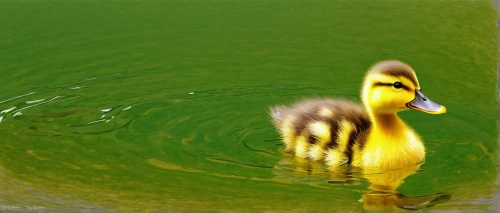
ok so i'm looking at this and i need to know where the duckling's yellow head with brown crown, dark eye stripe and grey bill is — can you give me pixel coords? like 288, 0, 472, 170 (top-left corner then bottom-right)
361, 61, 446, 114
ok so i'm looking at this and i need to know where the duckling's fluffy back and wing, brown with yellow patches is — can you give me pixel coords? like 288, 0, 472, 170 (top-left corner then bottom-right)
270, 99, 371, 165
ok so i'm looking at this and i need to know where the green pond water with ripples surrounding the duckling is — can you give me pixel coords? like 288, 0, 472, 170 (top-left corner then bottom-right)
0, 0, 498, 211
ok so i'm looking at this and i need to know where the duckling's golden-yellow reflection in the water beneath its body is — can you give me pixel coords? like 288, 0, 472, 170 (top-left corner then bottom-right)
275, 156, 451, 211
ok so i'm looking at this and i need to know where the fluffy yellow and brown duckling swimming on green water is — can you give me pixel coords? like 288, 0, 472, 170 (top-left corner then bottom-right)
270, 60, 446, 169
